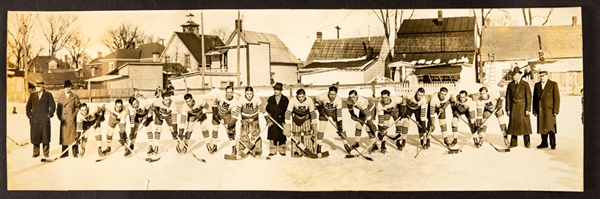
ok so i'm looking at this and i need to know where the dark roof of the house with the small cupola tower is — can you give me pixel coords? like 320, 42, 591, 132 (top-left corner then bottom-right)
175, 32, 224, 61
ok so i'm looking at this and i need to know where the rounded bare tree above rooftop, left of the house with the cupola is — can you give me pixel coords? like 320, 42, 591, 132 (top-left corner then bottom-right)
102, 22, 148, 51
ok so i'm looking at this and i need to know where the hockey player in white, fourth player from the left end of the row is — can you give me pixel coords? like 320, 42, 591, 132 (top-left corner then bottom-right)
148, 93, 177, 159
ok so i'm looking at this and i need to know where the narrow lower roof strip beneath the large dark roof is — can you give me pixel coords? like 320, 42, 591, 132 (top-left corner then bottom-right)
392, 51, 475, 65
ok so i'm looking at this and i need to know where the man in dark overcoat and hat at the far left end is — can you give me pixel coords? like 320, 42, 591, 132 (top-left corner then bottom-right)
25, 81, 56, 158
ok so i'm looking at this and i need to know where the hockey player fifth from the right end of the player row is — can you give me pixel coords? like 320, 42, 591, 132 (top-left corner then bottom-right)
376, 90, 402, 153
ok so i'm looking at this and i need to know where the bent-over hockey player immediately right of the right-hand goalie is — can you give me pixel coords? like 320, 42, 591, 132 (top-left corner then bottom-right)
315, 86, 352, 153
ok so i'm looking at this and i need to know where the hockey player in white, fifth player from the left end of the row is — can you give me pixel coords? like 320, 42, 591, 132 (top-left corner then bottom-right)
175, 93, 211, 153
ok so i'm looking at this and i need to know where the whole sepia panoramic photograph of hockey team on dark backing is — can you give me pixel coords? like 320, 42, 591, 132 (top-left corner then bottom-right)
5, 7, 590, 192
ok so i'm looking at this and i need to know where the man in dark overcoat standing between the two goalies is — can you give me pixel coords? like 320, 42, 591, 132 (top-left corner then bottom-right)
266, 82, 289, 156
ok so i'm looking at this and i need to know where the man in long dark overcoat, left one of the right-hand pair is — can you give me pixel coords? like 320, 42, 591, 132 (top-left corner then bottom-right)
506, 66, 532, 148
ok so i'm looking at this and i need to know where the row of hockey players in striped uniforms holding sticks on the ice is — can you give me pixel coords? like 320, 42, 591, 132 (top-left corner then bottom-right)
32, 86, 529, 162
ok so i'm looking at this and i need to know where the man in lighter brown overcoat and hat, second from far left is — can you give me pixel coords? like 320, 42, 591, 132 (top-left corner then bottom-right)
56, 80, 81, 158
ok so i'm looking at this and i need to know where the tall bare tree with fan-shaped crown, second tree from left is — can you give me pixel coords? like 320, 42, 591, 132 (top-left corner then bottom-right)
40, 14, 78, 57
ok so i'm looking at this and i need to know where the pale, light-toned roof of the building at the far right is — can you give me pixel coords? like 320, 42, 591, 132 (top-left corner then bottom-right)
481, 26, 583, 61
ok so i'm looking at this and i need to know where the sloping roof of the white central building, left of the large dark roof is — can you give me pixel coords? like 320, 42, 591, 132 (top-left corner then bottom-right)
306, 36, 385, 63
